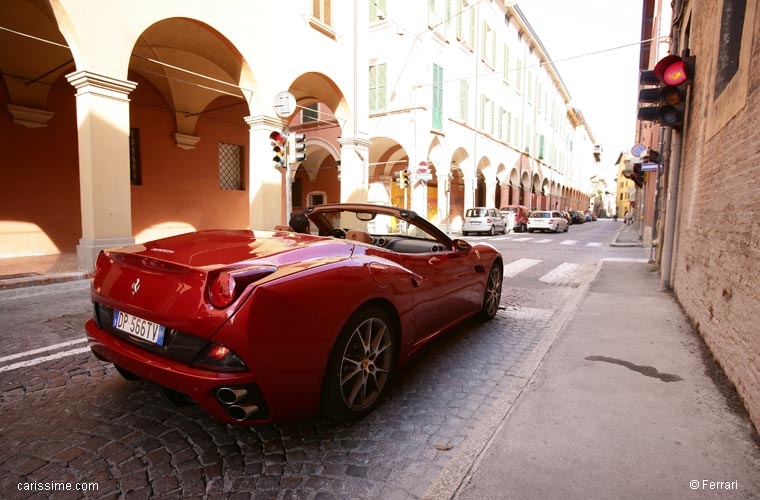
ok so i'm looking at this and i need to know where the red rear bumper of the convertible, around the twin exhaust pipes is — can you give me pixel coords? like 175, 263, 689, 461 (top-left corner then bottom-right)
85, 320, 271, 425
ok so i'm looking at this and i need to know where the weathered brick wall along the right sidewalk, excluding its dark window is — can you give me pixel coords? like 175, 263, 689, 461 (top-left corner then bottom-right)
672, 2, 760, 429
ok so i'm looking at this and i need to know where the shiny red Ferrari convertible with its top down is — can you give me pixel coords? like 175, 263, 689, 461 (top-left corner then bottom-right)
86, 204, 503, 424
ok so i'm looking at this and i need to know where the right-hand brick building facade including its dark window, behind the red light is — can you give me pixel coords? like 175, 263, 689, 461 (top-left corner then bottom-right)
644, 0, 760, 429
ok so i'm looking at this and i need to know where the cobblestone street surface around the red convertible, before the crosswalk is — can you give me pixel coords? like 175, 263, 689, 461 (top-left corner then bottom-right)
0, 272, 581, 500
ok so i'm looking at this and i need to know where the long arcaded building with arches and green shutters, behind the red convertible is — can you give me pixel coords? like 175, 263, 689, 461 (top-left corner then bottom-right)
0, 0, 598, 269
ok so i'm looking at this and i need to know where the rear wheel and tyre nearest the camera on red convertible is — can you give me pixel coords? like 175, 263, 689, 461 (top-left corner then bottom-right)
322, 306, 398, 422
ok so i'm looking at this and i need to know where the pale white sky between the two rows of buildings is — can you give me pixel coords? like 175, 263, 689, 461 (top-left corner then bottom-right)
515, 0, 643, 181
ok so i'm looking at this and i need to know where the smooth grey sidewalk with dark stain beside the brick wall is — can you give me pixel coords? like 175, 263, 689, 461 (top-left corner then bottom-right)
455, 260, 760, 500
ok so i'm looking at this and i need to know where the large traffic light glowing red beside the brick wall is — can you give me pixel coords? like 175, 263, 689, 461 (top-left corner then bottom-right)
638, 54, 694, 130
